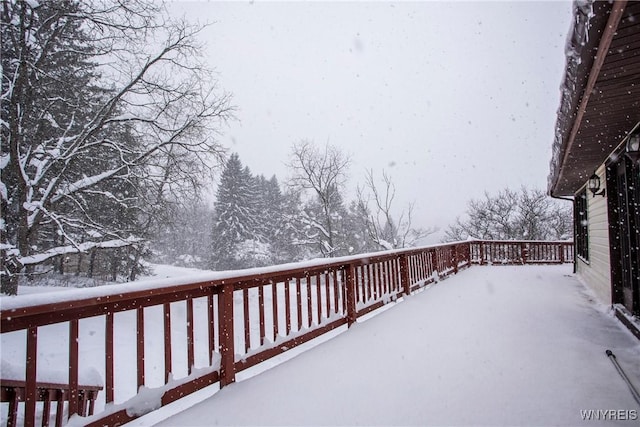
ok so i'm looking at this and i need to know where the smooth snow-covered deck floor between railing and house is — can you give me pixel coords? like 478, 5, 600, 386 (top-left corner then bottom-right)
152, 265, 640, 426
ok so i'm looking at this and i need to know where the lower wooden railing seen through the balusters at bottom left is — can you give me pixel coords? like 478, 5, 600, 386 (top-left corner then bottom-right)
0, 379, 102, 427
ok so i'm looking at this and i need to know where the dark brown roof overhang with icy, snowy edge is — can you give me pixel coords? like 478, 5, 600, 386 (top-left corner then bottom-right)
549, 1, 640, 196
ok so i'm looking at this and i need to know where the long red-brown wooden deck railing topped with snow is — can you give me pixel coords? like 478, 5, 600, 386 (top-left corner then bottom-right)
0, 241, 573, 426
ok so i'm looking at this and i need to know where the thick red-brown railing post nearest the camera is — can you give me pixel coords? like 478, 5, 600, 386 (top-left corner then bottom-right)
218, 283, 236, 388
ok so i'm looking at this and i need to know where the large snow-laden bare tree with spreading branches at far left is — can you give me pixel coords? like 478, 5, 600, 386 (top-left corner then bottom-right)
0, 0, 232, 293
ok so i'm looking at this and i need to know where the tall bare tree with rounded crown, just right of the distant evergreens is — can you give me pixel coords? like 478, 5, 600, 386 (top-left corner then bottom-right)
288, 141, 350, 256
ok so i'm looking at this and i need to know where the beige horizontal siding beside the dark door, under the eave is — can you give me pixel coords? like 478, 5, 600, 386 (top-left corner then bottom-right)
576, 166, 612, 304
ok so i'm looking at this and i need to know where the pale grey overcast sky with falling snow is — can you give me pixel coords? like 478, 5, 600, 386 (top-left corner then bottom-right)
170, 1, 571, 242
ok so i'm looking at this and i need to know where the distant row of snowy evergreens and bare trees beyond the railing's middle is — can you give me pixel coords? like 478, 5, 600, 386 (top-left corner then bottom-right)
154, 145, 434, 270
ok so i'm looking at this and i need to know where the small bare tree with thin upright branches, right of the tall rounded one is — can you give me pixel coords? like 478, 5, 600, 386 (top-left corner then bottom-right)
357, 170, 436, 249
